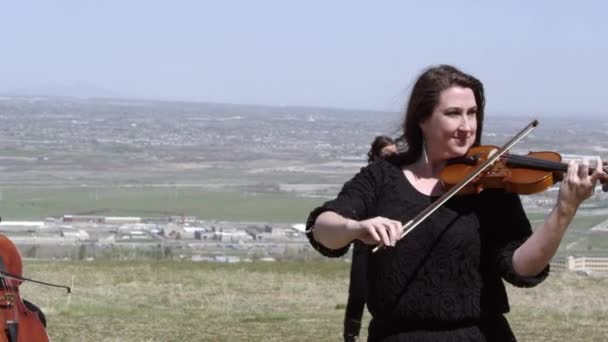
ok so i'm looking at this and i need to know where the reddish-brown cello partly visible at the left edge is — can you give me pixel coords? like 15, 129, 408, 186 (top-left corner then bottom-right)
0, 234, 49, 342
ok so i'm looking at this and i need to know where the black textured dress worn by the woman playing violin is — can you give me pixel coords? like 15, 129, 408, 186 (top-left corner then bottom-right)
307, 161, 549, 341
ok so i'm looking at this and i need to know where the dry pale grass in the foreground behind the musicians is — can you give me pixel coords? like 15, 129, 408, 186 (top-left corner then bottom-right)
16, 260, 608, 341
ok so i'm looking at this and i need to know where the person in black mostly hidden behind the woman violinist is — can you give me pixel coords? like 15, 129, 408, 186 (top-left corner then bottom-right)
343, 135, 397, 342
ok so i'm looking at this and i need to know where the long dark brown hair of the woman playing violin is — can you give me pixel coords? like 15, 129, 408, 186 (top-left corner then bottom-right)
391, 65, 485, 164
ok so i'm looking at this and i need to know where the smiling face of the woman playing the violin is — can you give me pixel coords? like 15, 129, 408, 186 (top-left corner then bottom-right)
420, 86, 477, 161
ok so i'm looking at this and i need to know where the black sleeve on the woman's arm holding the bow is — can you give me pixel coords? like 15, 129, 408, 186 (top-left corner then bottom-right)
306, 163, 382, 257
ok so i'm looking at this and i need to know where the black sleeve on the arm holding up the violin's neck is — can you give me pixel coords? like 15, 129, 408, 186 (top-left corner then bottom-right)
486, 191, 549, 287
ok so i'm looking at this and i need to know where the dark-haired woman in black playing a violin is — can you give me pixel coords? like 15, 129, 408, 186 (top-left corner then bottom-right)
307, 65, 607, 341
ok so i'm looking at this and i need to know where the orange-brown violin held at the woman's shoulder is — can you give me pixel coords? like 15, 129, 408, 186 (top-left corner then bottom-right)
439, 145, 608, 195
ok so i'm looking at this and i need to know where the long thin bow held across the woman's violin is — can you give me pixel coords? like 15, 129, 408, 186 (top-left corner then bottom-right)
372, 120, 538, 253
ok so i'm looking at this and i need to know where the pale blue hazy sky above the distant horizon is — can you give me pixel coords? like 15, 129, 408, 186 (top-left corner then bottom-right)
0, 0, 608, 118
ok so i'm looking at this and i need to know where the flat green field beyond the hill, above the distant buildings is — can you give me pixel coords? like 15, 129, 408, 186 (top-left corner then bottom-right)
0, 187, 323, 222
